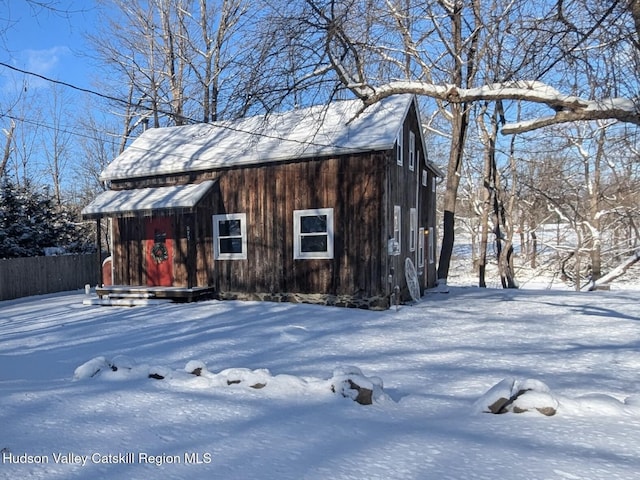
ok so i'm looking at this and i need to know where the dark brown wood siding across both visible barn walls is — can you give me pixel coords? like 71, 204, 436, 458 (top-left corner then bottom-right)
106, 96, 444, 299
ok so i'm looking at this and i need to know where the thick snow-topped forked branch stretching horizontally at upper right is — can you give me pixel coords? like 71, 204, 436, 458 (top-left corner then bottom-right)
356, 80, 640, 134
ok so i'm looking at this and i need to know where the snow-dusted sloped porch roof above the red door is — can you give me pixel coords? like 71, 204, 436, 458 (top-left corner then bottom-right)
82, 180, 216, 219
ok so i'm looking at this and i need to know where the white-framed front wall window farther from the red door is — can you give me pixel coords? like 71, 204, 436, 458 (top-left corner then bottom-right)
293, 208, 333, 260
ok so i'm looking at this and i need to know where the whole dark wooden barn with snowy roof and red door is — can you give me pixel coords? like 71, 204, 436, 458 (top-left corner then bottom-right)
83, 95, 442, 308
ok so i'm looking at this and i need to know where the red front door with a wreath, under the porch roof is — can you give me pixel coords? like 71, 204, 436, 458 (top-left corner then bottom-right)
145, 217, 173, 287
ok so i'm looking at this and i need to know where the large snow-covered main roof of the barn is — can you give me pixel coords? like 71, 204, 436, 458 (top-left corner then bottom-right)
101, 95, 414, 181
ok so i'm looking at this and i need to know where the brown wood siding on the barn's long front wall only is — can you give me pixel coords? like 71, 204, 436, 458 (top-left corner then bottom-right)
114, 152, 392, 297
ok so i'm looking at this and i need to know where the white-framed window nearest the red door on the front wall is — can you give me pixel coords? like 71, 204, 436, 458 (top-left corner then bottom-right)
213, 213, 247, 260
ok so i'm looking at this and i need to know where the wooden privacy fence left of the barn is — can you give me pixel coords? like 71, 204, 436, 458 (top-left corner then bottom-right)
0, 253, 100, 300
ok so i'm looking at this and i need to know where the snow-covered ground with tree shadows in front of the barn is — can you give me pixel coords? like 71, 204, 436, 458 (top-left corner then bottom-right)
0, 287, 640, 480
